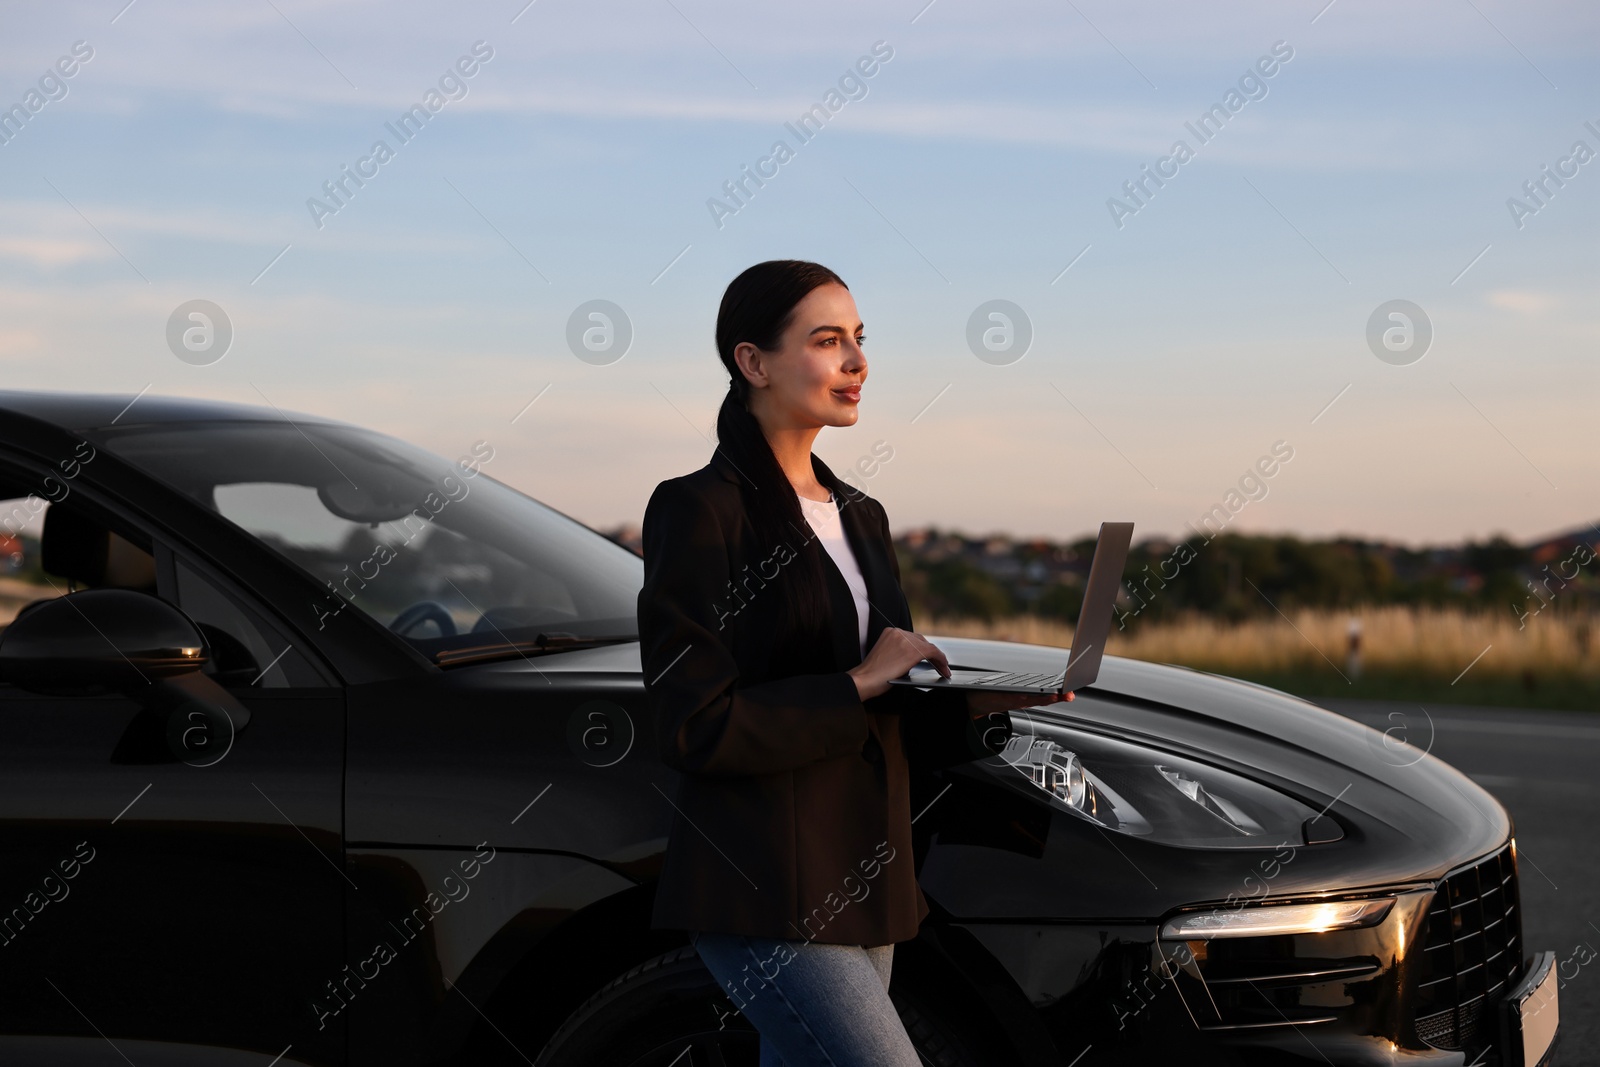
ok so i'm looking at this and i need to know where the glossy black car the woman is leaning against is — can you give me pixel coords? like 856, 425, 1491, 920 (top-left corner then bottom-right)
0, 392, 1557, 1067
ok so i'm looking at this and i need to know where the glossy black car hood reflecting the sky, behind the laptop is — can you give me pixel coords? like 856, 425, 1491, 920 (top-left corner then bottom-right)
472, 635, 1512, 913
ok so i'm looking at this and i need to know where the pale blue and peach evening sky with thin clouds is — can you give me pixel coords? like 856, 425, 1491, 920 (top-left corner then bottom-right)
0, 0, 1600, 544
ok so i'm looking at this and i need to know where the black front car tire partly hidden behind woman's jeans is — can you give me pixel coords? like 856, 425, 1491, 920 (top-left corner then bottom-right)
534, 945, 992, 1067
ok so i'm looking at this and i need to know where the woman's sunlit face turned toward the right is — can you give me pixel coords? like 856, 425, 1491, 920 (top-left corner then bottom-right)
734, 283, 867, 430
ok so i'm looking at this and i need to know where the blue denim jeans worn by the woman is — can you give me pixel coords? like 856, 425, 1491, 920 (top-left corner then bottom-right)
691, 933, 922, 1067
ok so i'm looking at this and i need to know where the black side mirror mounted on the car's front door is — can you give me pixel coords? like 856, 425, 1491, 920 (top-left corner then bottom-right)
0, 589, 250, 766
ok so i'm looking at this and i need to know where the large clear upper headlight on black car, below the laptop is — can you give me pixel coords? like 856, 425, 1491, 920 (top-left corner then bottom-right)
978, 712, 1318, 848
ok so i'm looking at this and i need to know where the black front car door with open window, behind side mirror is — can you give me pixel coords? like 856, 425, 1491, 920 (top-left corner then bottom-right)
0, 445, 350, 1067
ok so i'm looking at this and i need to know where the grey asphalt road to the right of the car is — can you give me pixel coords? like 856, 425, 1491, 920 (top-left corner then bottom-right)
1318, 701, 1600, 1067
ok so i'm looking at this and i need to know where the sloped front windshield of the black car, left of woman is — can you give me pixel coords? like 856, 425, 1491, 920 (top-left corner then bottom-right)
96, 421, 643, 659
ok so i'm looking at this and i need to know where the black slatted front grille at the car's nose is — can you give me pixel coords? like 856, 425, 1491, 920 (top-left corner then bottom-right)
1416, 846, 1522, 1056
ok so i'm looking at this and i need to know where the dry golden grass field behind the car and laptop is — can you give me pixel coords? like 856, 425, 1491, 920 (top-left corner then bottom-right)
917, 606, 1600, 710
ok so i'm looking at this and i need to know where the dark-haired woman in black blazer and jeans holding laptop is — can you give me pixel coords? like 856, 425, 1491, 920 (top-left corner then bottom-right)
638, 259, 1021, 1067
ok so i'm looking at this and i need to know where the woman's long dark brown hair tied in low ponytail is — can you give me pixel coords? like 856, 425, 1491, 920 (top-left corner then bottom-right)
717, 259, 850, 652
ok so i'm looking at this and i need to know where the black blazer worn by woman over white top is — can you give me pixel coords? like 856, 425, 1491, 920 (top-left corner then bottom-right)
638, 450, 995, 945
